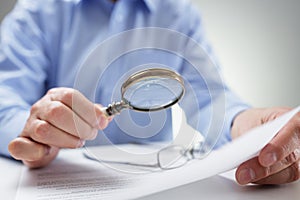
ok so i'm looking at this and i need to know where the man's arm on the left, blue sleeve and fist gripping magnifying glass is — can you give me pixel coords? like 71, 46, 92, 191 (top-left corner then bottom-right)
0, 1, 109, 167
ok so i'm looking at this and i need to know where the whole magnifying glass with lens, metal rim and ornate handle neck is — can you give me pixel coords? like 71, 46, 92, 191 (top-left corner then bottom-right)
102, 68, 185, 117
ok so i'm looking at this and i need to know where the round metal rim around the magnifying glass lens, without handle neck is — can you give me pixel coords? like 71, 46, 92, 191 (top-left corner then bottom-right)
121, 68, 185, 112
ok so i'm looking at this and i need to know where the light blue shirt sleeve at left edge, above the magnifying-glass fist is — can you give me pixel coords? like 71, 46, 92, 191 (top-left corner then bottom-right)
0, 1, 49, 156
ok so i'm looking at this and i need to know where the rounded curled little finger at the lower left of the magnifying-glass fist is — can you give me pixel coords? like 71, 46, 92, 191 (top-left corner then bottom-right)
8, 137, 50, 161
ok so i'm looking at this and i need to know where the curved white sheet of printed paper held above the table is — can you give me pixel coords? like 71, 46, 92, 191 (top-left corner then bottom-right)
16, 107, 300, 200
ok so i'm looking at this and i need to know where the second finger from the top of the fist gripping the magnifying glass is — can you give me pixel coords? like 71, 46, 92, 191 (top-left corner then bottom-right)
32, 101, 97, 140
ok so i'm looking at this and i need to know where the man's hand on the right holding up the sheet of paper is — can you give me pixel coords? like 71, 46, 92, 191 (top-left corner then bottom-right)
232, 108, 300, 185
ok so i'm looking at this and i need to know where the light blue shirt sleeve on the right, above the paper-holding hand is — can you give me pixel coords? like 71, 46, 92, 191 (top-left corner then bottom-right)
176, 3, 250, 150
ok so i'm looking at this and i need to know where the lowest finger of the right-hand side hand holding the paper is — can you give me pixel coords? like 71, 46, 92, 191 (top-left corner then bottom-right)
236, 149, 300, 185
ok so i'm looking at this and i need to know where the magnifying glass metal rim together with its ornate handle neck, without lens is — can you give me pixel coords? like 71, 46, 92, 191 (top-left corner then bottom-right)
102, 68, 185, 117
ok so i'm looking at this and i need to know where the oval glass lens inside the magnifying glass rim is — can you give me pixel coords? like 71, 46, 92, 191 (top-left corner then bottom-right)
123, 77, 183, 110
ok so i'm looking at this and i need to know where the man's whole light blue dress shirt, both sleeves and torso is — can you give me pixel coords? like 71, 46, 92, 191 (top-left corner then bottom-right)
0, 0, 248, 156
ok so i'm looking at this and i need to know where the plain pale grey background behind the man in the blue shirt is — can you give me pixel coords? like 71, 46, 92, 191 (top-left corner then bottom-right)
0, 0, 300, 107
